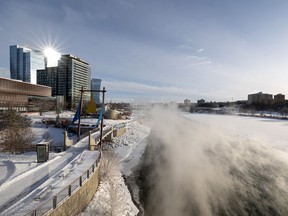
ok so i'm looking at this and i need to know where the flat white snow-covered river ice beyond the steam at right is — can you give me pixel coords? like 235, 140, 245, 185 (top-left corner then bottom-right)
182, 113, 288, 151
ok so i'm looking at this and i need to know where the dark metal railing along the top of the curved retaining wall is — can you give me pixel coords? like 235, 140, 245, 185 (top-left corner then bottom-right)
25, 155, 101, 216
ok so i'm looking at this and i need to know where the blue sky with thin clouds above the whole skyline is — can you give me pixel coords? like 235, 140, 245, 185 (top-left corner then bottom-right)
0, 0, 288, 102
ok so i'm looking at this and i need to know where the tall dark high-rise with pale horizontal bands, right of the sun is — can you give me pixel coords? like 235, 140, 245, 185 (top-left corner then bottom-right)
58, 54, 91, 109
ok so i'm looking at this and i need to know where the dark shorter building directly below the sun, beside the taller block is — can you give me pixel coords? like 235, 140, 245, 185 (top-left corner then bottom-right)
37, 67, 58, 97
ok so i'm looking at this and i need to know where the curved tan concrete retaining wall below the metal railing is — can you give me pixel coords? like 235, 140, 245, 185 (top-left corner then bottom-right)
48, 163, 100, 216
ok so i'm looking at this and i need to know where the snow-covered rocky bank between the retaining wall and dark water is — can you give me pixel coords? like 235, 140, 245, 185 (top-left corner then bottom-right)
80, 117, 150, 216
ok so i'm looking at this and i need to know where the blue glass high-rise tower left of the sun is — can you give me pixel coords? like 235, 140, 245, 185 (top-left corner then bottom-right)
10, 45, 45, 84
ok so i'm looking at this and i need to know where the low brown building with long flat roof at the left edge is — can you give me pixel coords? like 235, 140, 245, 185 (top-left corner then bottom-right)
0, 77, 51, 112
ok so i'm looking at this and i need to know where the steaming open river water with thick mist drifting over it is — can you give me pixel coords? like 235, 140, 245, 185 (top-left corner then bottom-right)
142, 109, 288, 216
